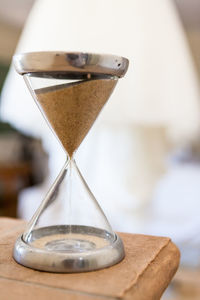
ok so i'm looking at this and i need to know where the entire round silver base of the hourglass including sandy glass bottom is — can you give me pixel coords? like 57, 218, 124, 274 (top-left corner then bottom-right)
13, 225, 125, 273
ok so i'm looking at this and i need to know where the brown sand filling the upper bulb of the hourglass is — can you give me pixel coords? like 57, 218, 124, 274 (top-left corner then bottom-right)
35, 79, 117, 157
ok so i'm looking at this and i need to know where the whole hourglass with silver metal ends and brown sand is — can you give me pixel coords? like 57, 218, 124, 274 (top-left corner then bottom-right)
13, 52, 128, 272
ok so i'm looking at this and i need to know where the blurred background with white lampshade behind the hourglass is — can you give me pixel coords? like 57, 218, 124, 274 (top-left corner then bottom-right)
0, 0, 200, 300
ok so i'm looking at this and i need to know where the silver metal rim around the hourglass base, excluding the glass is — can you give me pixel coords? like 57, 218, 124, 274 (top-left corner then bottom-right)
13, 234, 125, 273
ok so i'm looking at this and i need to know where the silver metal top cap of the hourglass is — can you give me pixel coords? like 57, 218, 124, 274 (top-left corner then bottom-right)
14, 51, 129, 78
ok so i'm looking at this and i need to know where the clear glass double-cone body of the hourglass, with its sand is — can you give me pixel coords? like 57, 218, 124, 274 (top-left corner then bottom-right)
23, 75, 116, 253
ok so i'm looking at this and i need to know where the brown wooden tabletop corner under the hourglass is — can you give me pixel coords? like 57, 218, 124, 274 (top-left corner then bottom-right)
0, 218, 179, 300
